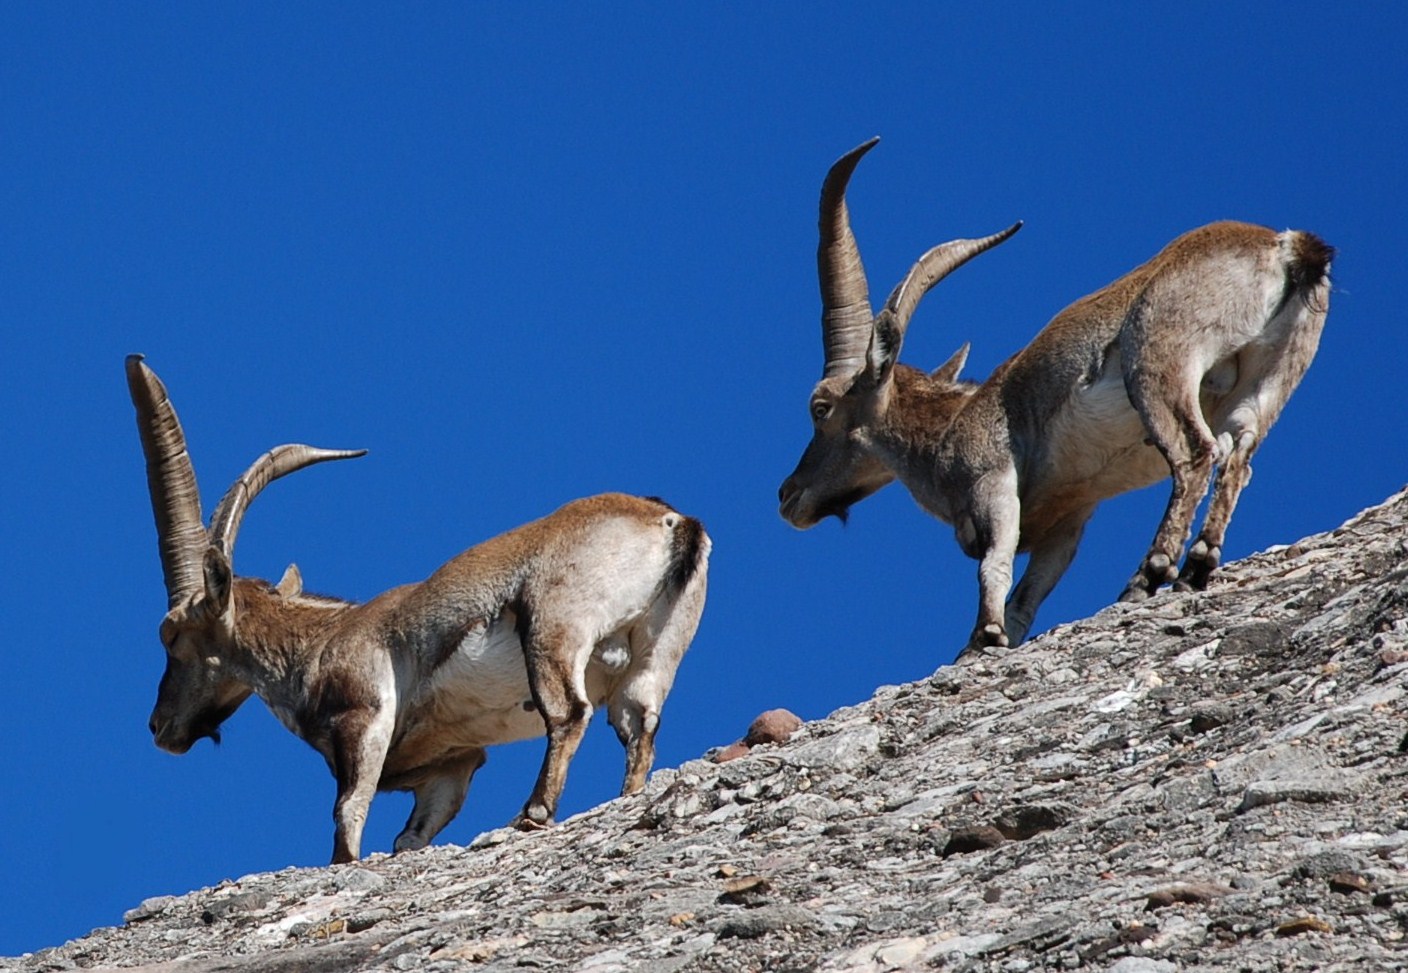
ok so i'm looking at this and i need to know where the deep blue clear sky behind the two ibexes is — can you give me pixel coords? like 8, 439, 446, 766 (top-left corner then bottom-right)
0, 3, 1408, 955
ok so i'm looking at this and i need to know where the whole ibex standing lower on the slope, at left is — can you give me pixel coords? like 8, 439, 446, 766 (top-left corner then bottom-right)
127, 355, 710, 863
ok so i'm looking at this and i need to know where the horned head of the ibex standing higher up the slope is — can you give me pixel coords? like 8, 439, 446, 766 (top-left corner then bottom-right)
777, 138, 1022, 529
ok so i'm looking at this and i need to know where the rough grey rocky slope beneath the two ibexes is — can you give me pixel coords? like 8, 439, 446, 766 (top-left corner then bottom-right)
11, 493, 1408, 973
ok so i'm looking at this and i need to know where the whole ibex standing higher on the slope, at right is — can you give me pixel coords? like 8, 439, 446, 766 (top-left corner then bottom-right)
779, 139, 1333, 648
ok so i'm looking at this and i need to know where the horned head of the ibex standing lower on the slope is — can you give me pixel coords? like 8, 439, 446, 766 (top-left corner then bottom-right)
127, 355, 366, 753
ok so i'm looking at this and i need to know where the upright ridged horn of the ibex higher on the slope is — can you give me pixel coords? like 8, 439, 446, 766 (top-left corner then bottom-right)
817, 135, 880, 377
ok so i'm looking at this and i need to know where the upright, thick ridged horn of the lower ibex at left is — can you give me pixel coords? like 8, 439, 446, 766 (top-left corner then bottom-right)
127, 355, 210, 607
